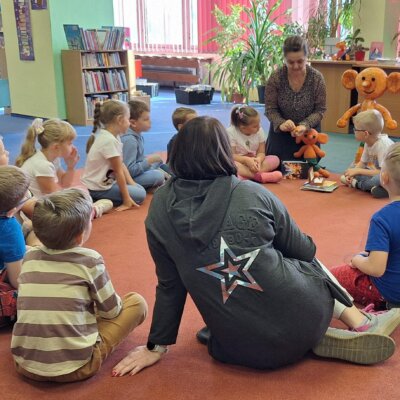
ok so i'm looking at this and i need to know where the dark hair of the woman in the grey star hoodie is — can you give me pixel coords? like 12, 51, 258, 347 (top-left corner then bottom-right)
170, 116, 237, 180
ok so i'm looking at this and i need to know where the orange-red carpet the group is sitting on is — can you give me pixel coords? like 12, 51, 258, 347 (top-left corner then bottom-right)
0, 177, 400, 400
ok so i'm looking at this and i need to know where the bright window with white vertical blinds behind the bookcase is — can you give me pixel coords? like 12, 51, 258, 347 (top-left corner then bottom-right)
114, 0, 198, 53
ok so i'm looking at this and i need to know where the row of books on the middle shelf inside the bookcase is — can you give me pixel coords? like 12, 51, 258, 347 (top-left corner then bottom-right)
82, 69, 128, 93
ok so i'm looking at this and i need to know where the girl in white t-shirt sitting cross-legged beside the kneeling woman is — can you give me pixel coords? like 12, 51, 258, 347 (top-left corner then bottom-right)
227, 105, 282, 183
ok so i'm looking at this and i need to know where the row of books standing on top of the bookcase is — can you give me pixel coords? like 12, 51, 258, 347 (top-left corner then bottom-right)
64, 24, 130, 51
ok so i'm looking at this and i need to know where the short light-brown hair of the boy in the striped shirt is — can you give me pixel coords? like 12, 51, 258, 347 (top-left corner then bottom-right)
32, 188, 93, 250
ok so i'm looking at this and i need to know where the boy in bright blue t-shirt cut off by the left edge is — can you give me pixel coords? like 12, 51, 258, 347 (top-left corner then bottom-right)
0, 165, 29, 288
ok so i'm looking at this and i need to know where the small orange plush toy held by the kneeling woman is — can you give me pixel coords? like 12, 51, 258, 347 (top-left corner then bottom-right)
293, 129, 329, 178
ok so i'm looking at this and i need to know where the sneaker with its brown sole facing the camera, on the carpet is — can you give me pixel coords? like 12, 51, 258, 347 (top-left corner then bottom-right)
312, 328, 396, 365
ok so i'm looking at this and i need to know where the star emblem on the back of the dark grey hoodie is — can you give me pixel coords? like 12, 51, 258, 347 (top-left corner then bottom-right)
197, 237, 263, 303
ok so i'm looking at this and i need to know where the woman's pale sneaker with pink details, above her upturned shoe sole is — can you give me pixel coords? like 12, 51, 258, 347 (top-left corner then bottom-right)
352, 304, 400, 335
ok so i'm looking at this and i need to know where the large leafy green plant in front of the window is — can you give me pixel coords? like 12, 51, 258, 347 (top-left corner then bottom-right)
211, 0, 301, 100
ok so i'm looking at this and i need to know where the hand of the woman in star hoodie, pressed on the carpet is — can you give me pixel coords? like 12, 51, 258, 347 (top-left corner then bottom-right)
111, 346, 161, 376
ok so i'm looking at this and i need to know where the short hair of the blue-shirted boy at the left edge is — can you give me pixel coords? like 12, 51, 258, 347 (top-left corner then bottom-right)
0, 165, 29, 214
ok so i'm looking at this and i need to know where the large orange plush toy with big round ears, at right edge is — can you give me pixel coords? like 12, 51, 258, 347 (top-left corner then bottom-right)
337, 67, 400, 129
